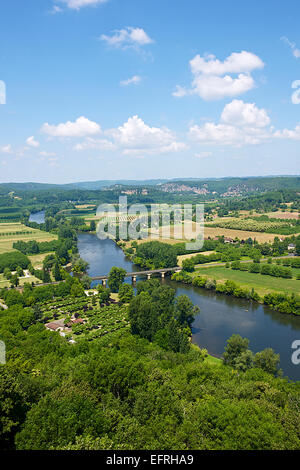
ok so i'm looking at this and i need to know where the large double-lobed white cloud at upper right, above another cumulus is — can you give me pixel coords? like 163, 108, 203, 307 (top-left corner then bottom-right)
173, 51, 264, 101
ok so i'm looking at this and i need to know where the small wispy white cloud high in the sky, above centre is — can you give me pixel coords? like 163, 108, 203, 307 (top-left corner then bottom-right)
100, 27, 154, 49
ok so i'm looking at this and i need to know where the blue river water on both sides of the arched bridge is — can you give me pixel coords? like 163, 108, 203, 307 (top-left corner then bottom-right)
78, 234, 300, 380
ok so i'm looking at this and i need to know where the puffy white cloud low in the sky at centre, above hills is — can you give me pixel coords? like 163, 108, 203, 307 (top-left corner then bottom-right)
110, 116, 187, 155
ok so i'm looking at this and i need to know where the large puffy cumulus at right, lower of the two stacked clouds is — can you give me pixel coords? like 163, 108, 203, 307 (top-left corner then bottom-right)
189, 100, 271, 147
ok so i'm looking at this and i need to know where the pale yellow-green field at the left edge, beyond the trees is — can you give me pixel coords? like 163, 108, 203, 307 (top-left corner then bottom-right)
0, 223, 57, 254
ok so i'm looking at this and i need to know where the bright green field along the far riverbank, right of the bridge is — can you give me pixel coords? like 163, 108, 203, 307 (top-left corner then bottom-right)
194, 266, 300, 295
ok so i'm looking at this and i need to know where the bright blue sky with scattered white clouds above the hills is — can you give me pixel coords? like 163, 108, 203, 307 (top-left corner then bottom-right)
0, 0, 300, 183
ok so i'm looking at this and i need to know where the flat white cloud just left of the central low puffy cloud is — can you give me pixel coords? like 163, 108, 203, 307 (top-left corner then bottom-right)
41, 116, 101, 137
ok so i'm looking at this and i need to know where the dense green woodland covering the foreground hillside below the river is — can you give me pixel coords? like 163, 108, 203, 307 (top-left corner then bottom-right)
0, 281, 300, 450
